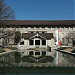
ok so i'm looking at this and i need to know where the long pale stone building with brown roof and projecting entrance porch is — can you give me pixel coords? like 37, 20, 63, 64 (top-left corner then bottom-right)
0, 20, 75, 55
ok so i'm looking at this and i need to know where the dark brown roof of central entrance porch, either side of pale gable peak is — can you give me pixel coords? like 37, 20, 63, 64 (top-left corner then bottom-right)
22, 33, 53, 39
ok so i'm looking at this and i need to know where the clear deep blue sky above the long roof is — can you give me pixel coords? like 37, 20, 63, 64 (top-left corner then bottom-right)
6, 0, 75, 20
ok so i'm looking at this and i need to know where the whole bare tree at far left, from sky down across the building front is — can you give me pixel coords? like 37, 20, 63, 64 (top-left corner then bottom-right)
0, 0, 15, 46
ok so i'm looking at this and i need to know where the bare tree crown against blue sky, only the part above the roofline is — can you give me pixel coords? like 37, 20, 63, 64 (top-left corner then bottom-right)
0, 0, 15, 20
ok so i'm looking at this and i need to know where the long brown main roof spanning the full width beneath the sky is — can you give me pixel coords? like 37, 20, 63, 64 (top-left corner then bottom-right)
0, 20, 75, 25
